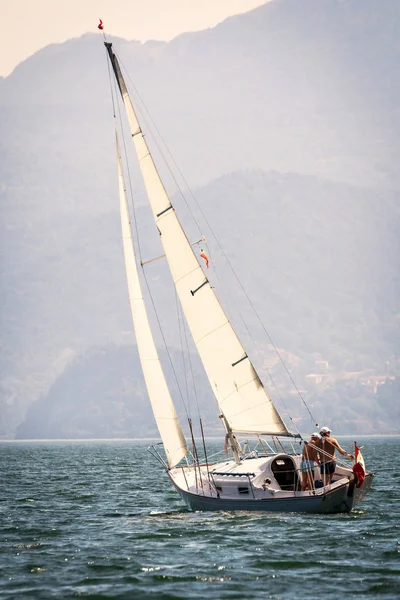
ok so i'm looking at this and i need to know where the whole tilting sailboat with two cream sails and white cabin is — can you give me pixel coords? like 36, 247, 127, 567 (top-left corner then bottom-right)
99, 34, 373, 513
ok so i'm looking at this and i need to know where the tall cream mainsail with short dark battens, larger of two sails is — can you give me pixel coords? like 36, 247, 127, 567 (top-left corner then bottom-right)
105, 42, 290, 435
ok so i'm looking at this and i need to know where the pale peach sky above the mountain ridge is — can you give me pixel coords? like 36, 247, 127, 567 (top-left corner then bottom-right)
0, 0, 271, 76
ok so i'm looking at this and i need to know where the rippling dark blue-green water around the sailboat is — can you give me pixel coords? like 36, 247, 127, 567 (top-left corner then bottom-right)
0, 438, 400, 600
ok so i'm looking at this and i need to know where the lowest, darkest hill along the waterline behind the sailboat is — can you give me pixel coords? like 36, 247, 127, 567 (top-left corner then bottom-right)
16, 346, 400, 444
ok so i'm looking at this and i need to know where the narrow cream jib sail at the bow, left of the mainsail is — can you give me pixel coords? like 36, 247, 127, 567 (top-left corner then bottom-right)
116, 133, 188, 467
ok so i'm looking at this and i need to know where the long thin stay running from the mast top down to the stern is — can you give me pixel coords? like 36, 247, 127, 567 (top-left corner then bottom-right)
114, 49, 317, 424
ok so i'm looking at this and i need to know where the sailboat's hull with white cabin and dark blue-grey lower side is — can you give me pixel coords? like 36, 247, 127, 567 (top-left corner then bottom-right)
168, 454, 373, 513
